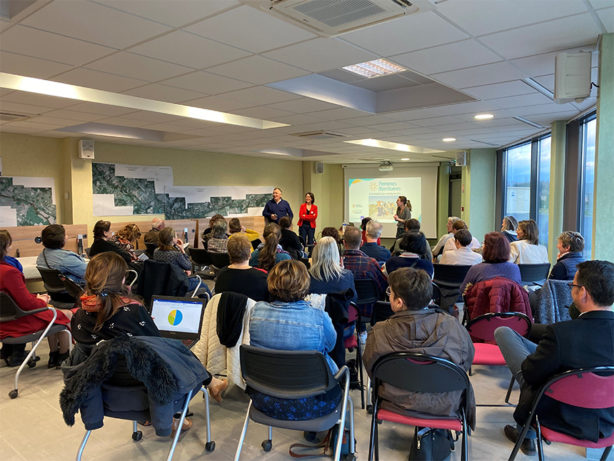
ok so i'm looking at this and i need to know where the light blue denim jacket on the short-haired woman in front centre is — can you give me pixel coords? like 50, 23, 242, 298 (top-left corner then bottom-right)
249, 301, 338, 373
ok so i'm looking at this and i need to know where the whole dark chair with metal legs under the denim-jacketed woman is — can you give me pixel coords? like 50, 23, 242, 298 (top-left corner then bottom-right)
235, 345, 355, 461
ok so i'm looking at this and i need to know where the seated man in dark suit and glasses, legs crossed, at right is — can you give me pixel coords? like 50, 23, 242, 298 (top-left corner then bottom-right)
495, 261, 614, 455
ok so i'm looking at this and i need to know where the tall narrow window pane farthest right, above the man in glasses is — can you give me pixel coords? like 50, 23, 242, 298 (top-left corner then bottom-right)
578, 114, 597, 258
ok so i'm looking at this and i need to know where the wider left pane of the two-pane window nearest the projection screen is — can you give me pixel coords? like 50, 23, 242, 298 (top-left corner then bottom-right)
503, 142, 531, 221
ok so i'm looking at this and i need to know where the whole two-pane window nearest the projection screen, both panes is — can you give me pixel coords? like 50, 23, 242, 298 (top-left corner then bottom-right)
503, 134, 551, 244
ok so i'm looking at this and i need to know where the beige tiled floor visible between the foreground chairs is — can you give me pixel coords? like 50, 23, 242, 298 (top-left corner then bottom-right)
0, 345, 614, 461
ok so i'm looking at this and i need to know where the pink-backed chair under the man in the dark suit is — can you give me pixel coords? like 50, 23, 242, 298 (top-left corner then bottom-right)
509, 366, 614, 461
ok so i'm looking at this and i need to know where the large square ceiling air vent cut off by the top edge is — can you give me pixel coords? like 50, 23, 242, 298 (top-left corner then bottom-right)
241, 0, 432, 37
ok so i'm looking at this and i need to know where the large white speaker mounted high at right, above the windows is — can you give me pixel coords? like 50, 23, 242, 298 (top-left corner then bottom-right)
554, 51, 592, 104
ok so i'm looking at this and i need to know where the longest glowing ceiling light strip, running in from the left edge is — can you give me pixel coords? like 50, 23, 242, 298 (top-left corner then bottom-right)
0, 72, 288, 130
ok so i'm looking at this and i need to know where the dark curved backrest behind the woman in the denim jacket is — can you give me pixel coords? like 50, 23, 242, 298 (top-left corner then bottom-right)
240, 345, 337, 399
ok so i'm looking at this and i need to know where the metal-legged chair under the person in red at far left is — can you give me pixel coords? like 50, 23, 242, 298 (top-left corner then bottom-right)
0, 292, 72, 399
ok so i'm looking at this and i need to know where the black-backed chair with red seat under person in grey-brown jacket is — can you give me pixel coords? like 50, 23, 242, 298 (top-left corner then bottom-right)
369, 352, 471, 461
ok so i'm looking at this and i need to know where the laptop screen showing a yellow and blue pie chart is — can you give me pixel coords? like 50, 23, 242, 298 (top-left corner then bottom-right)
151, 296, 205, 340
